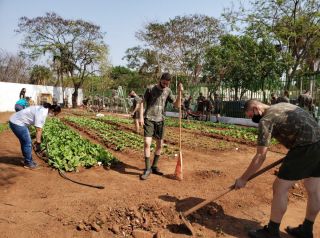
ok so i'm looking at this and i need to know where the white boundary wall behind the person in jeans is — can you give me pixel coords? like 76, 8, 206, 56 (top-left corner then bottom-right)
0, 82, 83, 112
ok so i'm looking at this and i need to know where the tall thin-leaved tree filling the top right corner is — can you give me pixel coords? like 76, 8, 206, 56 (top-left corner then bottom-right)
226, 0, 320, 89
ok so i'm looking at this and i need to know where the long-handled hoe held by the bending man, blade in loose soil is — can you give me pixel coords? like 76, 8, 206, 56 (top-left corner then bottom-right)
179, 158, 284, 235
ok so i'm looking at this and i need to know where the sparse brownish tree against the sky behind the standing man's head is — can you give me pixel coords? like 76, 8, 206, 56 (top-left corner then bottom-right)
137, 15, 222, 83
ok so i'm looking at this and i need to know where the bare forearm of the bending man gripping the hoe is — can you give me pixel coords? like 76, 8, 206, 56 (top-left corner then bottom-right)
234, 146, 268, 189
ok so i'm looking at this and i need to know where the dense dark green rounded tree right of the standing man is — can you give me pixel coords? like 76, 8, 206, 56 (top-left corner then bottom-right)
204, 34, 283, 100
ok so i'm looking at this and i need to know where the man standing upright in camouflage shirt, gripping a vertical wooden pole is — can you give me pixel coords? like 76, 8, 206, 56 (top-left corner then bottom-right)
140, 73, 183, 180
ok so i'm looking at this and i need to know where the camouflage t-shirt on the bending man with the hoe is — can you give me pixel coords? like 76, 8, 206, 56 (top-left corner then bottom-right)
258, 103, 320, 149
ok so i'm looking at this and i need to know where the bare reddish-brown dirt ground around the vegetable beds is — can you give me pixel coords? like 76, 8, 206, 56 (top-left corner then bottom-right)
0, 110, 320, 238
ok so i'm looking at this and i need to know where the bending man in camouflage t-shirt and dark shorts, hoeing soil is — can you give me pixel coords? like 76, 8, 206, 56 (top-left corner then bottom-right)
234, 100, 320, 238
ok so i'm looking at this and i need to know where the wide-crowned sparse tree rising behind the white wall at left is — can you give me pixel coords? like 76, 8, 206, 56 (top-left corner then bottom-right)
17, 13, 108, 107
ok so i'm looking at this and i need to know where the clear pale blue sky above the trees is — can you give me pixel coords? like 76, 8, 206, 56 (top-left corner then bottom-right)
0, 0, 242, 65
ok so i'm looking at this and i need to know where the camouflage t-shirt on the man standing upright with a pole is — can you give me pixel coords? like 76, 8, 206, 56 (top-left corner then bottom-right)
143, 85, 175, 122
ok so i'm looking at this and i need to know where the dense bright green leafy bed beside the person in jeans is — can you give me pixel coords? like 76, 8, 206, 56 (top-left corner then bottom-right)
42, 119, 117, 171
